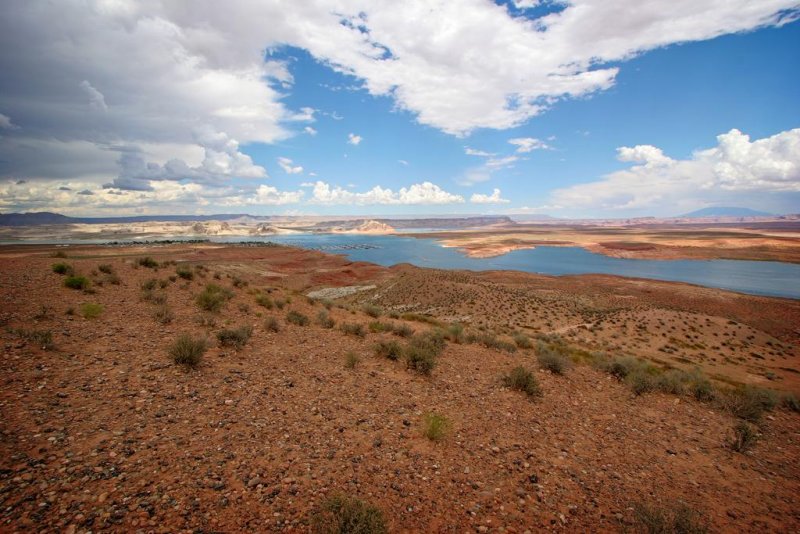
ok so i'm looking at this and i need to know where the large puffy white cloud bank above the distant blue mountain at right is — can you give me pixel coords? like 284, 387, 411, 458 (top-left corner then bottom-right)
552, 128, 800, 215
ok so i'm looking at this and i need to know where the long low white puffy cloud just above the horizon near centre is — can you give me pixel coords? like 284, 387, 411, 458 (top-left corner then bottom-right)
311, 181, 464, 206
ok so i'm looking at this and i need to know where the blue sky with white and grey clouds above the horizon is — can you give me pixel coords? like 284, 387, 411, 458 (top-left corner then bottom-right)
0, 0, 800, 218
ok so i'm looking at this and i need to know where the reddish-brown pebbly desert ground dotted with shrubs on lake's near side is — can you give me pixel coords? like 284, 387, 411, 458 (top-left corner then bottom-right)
0, 245, 800, 533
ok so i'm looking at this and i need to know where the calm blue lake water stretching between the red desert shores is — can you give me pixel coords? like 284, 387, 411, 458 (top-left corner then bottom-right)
206, 234, 800, 299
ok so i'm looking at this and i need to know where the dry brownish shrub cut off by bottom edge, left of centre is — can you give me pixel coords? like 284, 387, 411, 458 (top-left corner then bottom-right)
311, 495, 388, 534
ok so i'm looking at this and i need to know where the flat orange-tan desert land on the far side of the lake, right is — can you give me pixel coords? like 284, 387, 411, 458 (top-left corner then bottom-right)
407, 219, 800, 263
